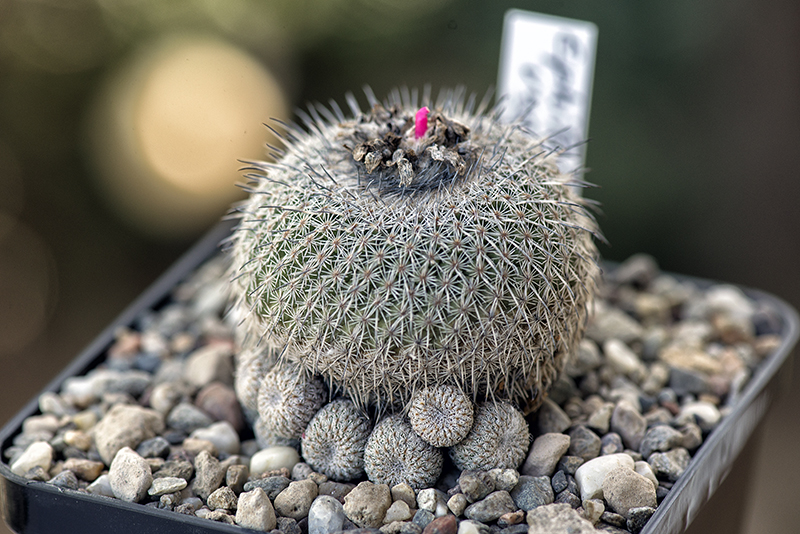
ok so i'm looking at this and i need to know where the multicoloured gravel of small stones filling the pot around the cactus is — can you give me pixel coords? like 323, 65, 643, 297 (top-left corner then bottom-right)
3, 255, 780, 534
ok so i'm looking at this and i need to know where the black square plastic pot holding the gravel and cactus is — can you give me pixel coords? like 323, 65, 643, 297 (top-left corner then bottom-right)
0, 223, 800, 534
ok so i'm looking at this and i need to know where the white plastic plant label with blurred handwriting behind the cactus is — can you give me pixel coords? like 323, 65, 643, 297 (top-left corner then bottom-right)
497, 9, 597, 172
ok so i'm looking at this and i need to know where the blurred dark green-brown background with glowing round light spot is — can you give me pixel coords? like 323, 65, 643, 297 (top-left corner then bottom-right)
0, 0, 800, 532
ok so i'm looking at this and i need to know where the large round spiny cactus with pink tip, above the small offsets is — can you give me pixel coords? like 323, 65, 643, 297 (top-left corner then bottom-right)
225, 87, 599, 412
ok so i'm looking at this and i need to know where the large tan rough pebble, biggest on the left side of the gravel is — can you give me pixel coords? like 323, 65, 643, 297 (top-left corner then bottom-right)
92, 404, 164, 465
